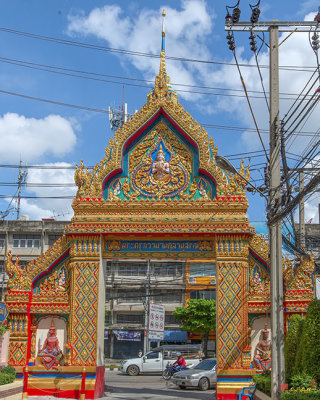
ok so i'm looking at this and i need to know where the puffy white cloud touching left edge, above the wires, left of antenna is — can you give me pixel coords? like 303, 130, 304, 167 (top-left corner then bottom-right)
0, 113, 76, 162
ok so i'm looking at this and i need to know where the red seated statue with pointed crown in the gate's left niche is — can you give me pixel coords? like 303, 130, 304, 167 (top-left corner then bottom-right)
38, 320, 63, 370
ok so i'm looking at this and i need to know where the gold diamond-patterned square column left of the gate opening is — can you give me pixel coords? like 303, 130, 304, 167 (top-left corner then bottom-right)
68, 235, 105, 398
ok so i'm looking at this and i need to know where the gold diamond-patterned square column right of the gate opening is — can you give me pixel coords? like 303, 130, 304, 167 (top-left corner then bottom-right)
217, 235, 253, 400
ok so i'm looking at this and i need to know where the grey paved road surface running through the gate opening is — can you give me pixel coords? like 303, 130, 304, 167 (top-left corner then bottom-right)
29, 371, 216, 400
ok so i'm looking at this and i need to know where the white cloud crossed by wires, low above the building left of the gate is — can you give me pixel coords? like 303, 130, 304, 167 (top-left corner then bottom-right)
21, 162, 76, 220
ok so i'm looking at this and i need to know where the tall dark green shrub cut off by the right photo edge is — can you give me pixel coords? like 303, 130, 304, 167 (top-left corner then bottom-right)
300, 299, 320, 384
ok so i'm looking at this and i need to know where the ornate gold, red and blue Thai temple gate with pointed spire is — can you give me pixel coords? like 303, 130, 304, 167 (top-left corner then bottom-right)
6, 22, 312, 400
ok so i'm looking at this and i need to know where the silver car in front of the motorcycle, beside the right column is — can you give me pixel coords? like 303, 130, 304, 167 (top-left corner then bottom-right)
172, 358, 217, 390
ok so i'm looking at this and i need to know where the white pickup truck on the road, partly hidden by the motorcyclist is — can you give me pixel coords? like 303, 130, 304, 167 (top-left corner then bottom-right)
121, 349, 201, 376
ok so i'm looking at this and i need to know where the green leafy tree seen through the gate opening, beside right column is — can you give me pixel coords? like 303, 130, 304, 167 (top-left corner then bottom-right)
173, 299, 216, 355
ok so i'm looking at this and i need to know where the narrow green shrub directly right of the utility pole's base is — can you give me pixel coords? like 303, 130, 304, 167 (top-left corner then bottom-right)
284, 315, 303, 380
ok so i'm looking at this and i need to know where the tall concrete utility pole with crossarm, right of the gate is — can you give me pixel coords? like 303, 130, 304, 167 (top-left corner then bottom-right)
225, 14, 320, 400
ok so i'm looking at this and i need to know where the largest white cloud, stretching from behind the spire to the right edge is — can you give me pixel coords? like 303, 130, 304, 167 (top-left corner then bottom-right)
68, 4, 319, 228
